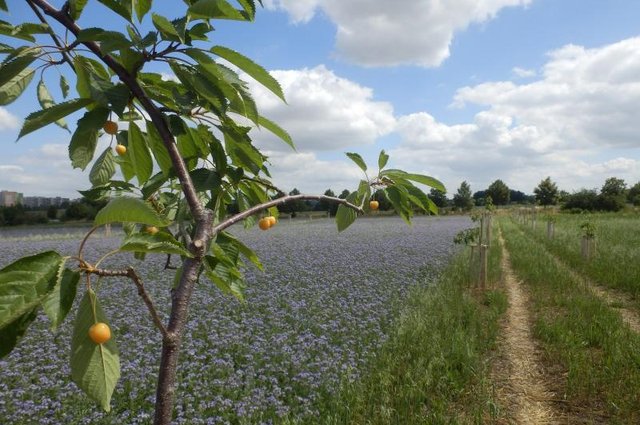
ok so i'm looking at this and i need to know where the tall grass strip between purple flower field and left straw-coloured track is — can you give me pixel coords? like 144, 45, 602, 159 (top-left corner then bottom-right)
321, 225, 507, 425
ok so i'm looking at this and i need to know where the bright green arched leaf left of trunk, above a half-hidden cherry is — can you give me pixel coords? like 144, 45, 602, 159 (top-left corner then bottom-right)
93, 197, 171, 227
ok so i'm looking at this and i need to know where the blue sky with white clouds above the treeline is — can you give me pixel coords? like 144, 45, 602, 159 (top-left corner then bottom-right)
0, 0, 640, 198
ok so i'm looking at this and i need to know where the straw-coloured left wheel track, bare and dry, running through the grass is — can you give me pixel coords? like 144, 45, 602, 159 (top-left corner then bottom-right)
494, 235, 561, 425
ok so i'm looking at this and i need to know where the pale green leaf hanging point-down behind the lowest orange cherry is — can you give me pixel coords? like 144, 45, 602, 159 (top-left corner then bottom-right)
71, 289, 120, 412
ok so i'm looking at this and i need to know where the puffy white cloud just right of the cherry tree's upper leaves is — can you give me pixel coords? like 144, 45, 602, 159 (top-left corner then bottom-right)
251, 65, 395, 151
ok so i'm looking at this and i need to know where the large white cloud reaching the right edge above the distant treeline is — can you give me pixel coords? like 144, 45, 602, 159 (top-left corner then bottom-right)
393, 38, 640, 192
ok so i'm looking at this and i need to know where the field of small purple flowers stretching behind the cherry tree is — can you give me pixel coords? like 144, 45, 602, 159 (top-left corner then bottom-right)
0, 217, 469, 424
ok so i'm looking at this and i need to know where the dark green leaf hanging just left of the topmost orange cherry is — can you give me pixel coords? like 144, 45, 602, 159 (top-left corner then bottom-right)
69, 107, 109, 170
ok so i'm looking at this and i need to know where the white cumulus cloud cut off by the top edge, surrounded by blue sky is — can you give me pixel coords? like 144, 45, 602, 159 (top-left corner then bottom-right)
265, 0, 532, 67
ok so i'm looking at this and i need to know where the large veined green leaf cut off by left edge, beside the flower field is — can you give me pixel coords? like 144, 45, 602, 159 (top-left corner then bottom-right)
0, 251, 64, 357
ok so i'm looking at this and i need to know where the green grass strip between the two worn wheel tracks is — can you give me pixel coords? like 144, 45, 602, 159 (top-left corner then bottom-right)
502, 220, 640, 424
